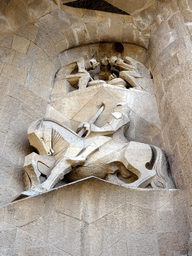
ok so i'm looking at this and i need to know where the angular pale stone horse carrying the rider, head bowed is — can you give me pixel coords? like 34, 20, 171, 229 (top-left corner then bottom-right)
24, 119, 174, 195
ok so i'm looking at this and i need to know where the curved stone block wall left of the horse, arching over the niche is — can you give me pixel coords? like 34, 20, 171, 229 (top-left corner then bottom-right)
0, 0, 149, 205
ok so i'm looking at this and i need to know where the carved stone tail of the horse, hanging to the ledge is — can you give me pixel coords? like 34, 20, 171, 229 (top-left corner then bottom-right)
151, 146, 174, 189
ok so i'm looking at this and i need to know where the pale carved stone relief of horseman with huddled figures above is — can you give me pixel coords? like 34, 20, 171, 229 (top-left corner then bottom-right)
19, 56, 174, 196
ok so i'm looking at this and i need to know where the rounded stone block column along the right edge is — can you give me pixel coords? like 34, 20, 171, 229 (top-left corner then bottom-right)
148, 0, 192, 230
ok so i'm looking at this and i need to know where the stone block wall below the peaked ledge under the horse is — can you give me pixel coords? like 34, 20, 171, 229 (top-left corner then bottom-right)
0, 177, 188, 256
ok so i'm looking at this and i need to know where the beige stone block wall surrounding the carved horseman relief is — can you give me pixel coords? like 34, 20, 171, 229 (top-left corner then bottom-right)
0, 0, 192, 256
